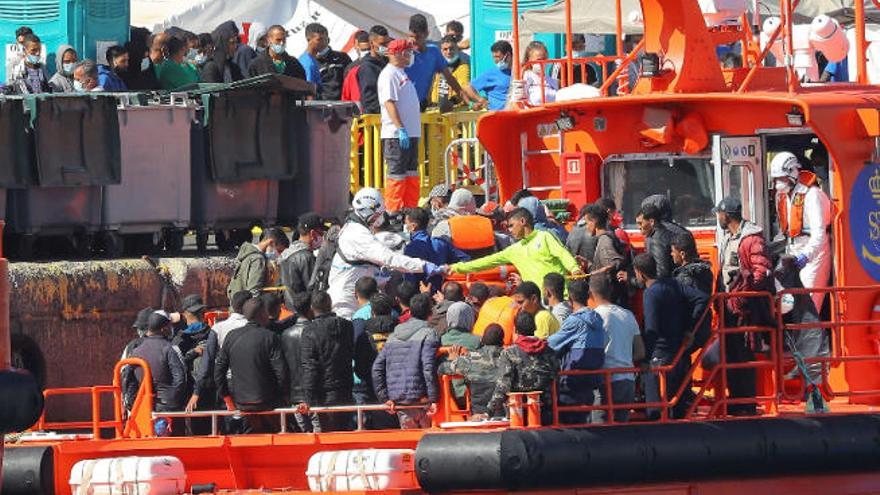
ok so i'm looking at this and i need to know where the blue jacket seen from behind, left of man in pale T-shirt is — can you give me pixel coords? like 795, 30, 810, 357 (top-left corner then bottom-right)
547, 308, 605, 392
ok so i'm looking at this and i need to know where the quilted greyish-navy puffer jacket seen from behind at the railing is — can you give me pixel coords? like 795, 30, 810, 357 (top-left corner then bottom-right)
373, 318, 440, 404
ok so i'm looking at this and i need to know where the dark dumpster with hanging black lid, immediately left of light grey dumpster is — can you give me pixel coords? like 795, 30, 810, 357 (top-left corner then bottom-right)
7, 94, 120, 258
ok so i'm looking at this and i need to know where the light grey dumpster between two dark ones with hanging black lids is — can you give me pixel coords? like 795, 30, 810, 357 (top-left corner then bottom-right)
101, 95, 196, 256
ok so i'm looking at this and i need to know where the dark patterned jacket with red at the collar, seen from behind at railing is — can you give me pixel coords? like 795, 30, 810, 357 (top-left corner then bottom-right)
488, 344, 559, 415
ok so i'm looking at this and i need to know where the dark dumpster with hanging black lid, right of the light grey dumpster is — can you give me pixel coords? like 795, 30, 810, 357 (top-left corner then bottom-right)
190, 76, 304, 251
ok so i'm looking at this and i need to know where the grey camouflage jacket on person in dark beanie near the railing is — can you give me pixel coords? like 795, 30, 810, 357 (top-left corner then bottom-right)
440, 345, 502, 414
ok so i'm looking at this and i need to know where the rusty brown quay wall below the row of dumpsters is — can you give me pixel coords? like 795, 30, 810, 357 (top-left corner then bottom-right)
9, 257, 233, 421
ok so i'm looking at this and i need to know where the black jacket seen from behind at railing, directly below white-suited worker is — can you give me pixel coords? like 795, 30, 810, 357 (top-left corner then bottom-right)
301, 313, 354, 406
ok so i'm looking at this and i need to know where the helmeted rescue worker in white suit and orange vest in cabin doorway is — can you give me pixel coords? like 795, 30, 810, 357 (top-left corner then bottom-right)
770, 151, 832, 311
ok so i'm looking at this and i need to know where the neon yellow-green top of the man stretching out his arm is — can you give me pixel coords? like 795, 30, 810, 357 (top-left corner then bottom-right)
450, 230, 580, 290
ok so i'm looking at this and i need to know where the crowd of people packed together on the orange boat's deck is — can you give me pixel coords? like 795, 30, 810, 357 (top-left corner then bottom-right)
117, 142, 828, 433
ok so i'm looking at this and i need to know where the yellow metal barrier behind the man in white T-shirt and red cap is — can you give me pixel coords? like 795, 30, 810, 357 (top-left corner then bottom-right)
351, 111, 484, 197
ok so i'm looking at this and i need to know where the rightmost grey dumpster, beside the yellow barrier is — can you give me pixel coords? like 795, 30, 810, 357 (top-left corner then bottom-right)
278, 101, 357, 225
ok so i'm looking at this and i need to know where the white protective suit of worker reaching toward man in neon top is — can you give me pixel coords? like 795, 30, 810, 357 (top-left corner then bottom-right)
327, 221, 425, 319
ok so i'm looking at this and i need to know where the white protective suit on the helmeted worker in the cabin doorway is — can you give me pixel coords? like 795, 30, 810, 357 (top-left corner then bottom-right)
785, 182, 832, 312
